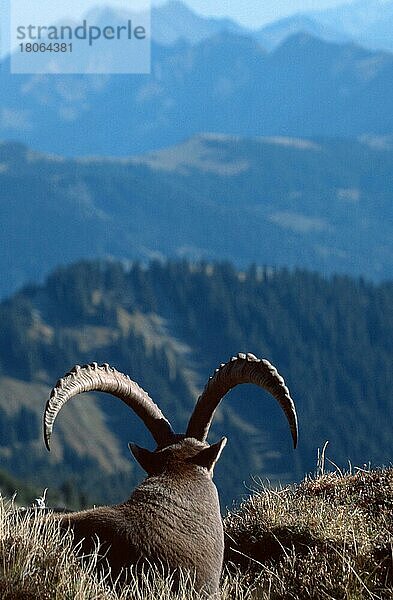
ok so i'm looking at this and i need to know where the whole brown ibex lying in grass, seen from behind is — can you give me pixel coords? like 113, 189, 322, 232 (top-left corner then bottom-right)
44, 354, 298, 597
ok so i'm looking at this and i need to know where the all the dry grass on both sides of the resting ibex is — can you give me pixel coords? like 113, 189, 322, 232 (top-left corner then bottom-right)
0, 469, 393, 600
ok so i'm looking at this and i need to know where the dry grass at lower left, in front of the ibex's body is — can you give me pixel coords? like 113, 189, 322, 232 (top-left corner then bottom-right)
0, 499, 250, 600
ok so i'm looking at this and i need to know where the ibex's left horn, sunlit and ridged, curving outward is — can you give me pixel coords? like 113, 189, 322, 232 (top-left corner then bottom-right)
44, 363, 175, 450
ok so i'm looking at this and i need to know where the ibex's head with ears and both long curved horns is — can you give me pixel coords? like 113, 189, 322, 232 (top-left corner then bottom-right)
44, 354, 298, 475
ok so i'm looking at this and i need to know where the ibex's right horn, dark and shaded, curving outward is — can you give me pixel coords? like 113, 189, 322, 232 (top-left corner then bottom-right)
186, 354, 298, 448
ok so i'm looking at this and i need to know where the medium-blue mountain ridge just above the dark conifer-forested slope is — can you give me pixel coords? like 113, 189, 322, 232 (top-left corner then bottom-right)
0, 134, 393, 295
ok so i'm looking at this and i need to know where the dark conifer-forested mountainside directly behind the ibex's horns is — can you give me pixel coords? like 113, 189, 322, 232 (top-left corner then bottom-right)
0, 261, 393, 504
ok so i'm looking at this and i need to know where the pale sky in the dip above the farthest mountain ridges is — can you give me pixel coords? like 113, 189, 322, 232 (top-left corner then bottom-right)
152, 0, 351, 28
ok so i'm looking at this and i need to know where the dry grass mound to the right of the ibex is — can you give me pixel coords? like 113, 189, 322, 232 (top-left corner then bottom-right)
226, 469, 393, 600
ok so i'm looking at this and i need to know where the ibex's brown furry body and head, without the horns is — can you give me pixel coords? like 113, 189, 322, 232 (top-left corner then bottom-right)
57, 438, 226, 595
